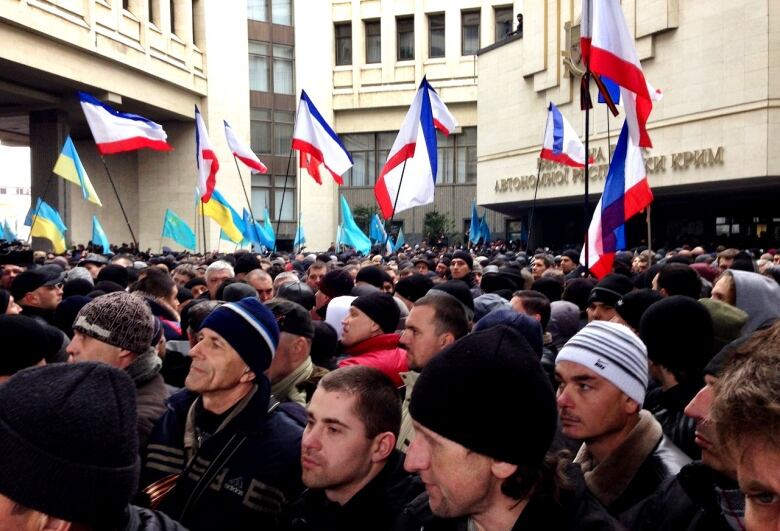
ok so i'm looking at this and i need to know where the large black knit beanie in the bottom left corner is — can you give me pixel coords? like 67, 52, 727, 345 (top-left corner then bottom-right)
0, 362, 140, 529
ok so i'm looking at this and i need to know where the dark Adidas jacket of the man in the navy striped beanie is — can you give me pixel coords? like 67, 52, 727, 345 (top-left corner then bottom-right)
140, 377, 303, 531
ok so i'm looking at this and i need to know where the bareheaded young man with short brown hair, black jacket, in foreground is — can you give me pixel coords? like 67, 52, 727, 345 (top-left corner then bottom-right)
290, 366, 423, 531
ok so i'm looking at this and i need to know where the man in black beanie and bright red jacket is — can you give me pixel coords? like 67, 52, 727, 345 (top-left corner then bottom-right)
339, 291, 409, 387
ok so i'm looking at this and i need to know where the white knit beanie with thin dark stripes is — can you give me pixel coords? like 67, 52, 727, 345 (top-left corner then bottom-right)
555, 321, 648, 406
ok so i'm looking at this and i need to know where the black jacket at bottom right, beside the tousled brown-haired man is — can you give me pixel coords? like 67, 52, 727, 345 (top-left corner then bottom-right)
620, 462, 737, 531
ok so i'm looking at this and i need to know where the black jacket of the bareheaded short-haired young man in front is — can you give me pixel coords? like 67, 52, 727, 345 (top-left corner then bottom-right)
289, 450, 423, 531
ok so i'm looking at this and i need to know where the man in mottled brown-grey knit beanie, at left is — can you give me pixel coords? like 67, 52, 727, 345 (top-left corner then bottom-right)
66, 291, 169, 451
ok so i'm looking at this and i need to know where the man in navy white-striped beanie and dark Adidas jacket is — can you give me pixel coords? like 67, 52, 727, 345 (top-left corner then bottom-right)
141, 297, 303, 531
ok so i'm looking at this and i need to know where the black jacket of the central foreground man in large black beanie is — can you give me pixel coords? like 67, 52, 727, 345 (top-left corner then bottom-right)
393, 465, 623, 531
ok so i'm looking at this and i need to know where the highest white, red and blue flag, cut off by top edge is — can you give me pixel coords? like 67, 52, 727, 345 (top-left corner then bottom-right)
580, 0, 653, 148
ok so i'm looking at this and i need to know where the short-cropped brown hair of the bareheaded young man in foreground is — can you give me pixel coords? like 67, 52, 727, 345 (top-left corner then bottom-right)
318, 365, 401, 439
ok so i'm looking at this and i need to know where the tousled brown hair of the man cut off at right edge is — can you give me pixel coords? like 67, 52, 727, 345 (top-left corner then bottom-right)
712, 321, 780, 449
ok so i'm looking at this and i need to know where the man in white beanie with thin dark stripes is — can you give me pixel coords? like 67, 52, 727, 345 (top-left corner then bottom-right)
555, 321, 690, 516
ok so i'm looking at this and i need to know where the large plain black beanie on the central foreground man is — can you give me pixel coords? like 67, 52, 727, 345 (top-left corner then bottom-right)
409, 325, 558, 465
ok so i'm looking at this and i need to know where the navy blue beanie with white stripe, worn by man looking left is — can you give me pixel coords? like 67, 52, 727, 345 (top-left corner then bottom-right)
200, 297, 279, 377
